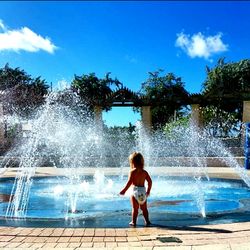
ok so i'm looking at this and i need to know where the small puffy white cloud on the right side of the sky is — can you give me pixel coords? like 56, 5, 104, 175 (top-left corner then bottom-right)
175, 32, 228, 59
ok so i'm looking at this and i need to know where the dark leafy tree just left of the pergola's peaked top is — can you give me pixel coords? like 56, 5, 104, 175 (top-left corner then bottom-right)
71, 73, 122, 111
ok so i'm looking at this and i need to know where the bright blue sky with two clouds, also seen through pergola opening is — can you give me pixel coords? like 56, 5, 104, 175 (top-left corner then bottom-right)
0, 1, 250, 125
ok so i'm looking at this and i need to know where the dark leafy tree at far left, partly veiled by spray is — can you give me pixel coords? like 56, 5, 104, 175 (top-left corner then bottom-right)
0, 64, 49, 116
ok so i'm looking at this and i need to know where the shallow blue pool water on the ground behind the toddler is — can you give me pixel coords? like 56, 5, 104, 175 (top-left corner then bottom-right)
0, 175, 250, 227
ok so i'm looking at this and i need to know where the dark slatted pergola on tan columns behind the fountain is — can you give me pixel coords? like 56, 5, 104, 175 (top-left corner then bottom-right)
94, 87, 250, 131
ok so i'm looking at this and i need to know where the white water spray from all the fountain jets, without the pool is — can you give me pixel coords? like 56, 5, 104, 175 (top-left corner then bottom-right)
1, 90, 250, 221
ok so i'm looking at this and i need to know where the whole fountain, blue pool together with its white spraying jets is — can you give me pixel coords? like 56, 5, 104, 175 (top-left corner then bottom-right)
0, 91, 250, 227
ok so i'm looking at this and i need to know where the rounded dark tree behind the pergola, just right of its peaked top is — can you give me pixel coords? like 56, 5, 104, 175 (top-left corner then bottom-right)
140, 70, 189, 128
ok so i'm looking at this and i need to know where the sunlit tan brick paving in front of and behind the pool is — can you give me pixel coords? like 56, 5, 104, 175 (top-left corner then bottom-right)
0, 168, 250, 250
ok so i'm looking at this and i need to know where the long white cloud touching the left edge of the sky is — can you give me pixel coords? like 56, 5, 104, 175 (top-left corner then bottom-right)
0, 20, 57, 54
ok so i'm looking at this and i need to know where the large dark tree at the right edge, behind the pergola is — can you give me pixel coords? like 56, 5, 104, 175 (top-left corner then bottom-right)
202, 58, 250, 136
